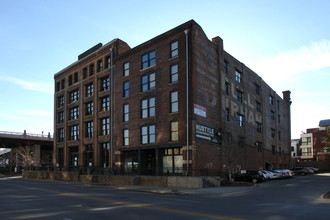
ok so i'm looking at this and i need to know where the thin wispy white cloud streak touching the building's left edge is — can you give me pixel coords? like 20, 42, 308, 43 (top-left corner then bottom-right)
0, 75, 54, 94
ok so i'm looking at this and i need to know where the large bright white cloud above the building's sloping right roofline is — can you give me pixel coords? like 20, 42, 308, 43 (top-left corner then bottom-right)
254, 39, 330, 83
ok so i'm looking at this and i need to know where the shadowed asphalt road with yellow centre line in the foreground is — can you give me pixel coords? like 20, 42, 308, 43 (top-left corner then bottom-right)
0, 175, 330, 220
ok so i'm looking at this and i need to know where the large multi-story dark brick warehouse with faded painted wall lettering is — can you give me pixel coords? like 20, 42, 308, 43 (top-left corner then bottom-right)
54, 20, 291, 175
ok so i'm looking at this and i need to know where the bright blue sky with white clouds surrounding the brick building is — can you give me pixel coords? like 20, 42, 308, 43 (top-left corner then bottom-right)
0, 0, 330, 138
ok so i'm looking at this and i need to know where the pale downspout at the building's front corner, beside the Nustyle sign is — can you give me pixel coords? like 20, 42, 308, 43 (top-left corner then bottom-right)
184, 29, 189, 176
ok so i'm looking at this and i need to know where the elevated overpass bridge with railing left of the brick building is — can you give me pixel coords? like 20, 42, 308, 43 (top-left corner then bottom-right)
0, 131, 53, 172
